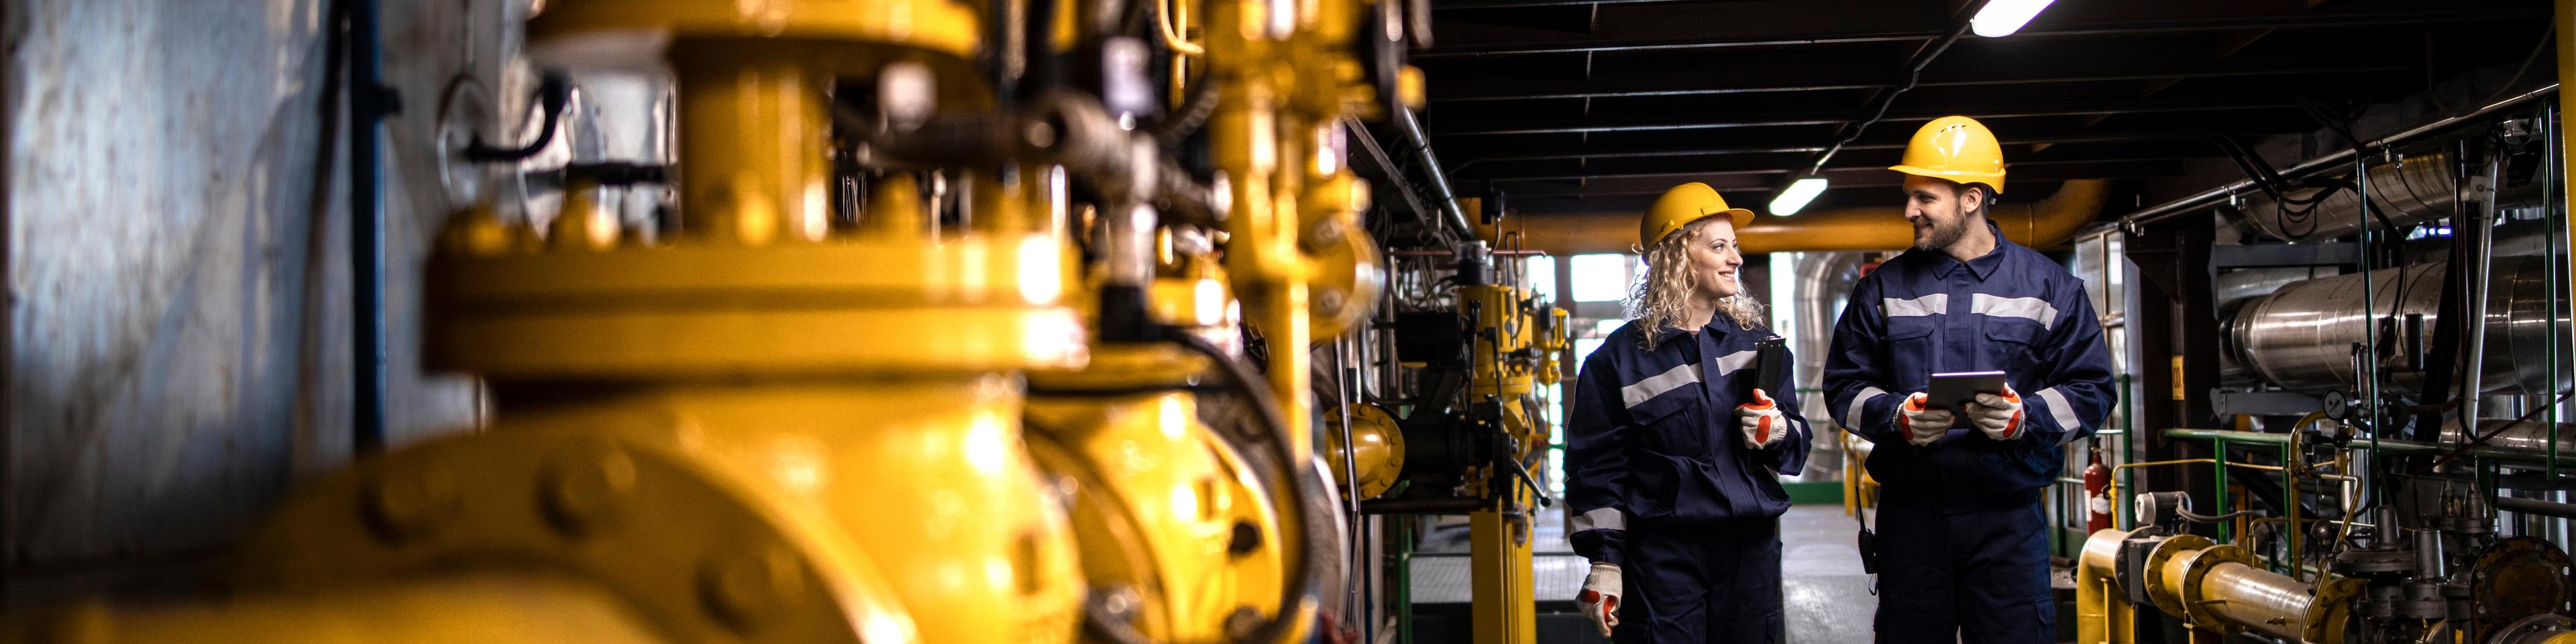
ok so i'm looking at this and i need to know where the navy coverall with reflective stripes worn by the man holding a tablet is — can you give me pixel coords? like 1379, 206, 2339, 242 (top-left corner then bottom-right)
1824, 224, 2117, 644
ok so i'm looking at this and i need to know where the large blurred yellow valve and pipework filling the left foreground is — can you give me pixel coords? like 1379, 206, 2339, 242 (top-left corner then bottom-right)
0, 0, 1421, 644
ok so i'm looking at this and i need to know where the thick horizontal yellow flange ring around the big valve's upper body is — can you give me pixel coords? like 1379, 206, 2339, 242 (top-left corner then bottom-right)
423, 234, 1087, 381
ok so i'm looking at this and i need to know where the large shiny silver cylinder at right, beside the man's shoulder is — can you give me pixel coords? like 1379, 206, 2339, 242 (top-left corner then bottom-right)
2226, 258, 2568, 394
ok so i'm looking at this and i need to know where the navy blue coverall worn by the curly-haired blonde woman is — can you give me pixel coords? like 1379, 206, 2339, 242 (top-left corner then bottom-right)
1566, 317, 1809, 644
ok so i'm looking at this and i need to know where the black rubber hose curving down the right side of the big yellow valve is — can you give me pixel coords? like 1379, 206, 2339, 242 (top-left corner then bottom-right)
1165, 330, 1340, 644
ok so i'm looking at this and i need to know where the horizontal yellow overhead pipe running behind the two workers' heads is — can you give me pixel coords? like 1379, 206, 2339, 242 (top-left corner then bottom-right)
1515, 180, 2110, 255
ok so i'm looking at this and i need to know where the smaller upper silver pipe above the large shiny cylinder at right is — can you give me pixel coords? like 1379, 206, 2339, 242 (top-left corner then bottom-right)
2236, 152, 2457, 242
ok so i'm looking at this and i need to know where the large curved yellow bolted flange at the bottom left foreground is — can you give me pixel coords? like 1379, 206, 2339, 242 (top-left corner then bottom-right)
234, 430, 917, 641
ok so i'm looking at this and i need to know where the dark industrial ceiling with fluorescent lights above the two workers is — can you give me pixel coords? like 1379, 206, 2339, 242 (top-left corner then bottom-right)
1411, 0, 2551, 224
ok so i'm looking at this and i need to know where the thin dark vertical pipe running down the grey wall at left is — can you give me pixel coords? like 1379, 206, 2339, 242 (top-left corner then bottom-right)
345, 0, 394, 453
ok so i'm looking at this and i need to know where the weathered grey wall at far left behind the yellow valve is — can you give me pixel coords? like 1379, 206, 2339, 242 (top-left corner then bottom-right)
0, 0, 525, 600
